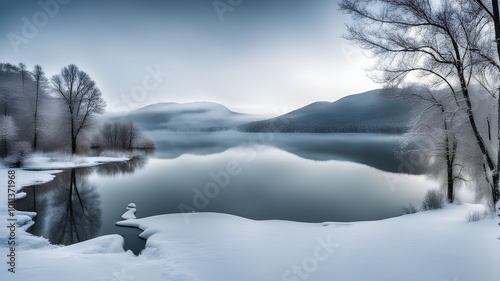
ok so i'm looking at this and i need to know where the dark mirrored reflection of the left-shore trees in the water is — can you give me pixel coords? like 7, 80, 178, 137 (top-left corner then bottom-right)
17, 157, 148, 245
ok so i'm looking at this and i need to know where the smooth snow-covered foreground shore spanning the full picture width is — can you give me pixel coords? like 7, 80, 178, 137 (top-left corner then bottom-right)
0, 202, 500, 281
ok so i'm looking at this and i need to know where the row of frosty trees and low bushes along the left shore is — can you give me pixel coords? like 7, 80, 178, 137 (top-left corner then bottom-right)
0, 63, 154, 166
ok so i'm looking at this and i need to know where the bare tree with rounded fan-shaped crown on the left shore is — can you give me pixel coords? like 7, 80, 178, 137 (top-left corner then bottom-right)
51, 64, 106, 154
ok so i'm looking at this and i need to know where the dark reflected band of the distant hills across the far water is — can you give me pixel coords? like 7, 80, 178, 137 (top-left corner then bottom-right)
150, 132, 426, 175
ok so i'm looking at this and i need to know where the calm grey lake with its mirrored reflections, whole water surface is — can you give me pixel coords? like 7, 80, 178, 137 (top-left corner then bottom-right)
18, 132, 436, 251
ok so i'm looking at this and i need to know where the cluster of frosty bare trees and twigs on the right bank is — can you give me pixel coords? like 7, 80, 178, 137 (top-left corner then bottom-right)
340, 0, 500, 209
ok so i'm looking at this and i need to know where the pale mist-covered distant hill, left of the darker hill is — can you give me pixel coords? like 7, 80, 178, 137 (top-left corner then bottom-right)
111, 102, 262, 132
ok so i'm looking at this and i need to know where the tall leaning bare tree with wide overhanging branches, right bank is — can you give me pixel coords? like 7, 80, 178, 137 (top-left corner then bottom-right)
340, 0, 498, 206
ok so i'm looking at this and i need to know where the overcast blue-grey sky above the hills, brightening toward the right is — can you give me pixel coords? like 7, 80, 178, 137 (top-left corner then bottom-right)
0, 0, 380, 114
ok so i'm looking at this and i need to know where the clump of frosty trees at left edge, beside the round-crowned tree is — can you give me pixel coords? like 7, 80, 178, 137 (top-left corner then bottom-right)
0, 63, 74, 154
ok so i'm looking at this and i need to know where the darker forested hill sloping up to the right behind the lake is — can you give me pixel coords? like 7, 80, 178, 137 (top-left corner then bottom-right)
239, 90, 411, 133
